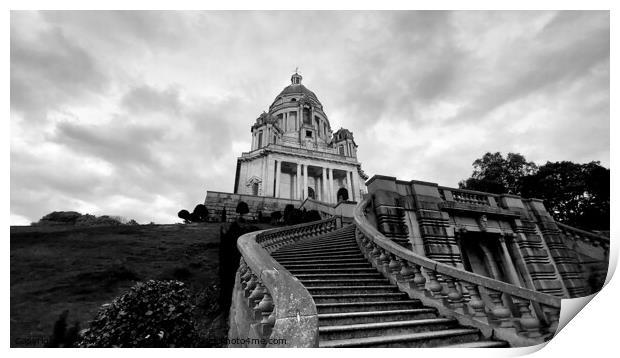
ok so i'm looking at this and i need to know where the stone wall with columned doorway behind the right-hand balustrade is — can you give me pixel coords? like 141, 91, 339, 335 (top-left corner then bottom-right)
367, 176, 603, 297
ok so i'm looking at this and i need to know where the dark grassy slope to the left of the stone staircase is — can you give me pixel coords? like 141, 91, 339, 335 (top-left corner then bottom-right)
10, 224, 268, 347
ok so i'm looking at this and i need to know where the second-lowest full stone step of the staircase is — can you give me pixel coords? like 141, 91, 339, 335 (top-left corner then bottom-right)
319, 318, 458, 341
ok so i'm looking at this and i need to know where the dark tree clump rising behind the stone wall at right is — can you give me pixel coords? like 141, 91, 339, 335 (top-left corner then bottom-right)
459, 153, 610, 230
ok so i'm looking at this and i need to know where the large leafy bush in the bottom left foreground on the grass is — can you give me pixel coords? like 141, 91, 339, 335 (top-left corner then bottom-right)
79, 280, 198, 347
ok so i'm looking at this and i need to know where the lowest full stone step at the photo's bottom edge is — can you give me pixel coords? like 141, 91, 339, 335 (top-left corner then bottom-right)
319, 328, 480, 348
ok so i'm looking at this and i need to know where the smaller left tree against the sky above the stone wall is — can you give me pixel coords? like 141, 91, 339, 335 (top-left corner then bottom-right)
459, 152, 537, 195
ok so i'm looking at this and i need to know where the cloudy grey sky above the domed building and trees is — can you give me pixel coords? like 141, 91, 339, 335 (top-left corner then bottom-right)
10, 11, 610, 225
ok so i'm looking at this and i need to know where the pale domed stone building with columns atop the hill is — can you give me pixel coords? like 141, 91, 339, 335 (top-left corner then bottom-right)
234, 73, 368, 204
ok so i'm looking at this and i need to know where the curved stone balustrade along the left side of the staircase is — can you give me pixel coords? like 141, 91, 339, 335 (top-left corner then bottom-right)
234, 218, 338, 347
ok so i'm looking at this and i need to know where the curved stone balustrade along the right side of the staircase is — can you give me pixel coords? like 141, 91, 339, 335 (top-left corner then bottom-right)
354, 199, 561, 346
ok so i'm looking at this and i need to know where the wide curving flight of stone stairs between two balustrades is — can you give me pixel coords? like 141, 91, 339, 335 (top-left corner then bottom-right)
271, 225, 508, 347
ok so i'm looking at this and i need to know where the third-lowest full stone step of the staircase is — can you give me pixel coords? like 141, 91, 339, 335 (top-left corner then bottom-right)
319, 308, 437, 326
